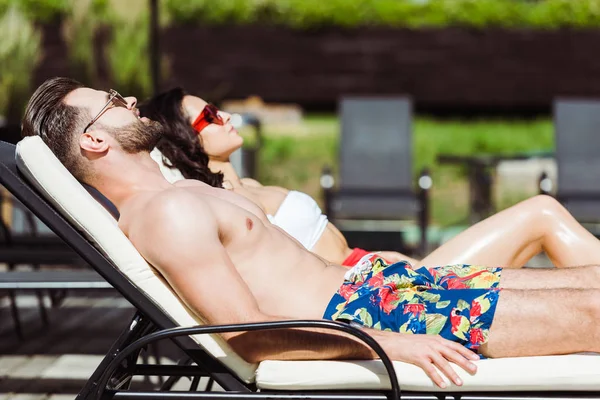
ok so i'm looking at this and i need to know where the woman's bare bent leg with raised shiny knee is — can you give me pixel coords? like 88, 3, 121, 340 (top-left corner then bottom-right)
421, 196, 600, 267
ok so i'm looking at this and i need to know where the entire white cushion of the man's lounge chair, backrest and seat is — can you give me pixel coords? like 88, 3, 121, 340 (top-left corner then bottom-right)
12, 137, 600, 391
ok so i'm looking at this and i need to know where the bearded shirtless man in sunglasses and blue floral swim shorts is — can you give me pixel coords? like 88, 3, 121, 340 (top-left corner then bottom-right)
23, 78, 600, 387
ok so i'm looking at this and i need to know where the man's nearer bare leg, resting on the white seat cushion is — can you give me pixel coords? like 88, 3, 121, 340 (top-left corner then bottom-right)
479, 289, 600, 357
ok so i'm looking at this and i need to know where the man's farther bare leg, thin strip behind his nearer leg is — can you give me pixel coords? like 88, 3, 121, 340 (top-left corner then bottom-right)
500, 266, 600, 290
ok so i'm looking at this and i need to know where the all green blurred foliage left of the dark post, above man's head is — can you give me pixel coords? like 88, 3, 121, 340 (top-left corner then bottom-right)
0, 0, 151, 120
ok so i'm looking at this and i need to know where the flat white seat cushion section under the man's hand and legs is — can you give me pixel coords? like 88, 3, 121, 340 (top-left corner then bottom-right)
256, 354, 600, 392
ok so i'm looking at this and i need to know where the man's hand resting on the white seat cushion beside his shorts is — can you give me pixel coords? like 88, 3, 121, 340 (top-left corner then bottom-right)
376, 330, 479, 389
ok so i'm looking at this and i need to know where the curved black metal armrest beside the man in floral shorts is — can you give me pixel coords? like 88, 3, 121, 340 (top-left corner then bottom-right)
96, 320, 400, 400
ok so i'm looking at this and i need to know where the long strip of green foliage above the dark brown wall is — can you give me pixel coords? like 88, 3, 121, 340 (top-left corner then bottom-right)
163, 0, 600, 29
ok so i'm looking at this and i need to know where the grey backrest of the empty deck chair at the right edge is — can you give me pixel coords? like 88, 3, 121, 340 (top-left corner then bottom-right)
554, 98, 600, 228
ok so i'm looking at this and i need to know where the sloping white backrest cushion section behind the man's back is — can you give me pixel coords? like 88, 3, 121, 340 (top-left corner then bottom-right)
17, 136, 256, 382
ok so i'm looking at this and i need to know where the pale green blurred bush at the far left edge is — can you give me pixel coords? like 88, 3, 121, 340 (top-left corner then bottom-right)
0, 4, 41, 117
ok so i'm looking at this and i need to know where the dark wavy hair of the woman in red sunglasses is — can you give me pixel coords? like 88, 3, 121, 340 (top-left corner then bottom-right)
139, 88, 223, 187
